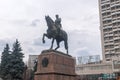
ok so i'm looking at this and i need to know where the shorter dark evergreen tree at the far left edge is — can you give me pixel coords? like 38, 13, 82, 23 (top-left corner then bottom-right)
0, 44, 10, 80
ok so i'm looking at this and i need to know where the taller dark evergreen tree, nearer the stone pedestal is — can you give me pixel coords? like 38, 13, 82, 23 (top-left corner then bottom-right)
10, 40, 24, 80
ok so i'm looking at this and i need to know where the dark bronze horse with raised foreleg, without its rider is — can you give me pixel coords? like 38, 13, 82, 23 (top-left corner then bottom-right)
42, 16, 68, 54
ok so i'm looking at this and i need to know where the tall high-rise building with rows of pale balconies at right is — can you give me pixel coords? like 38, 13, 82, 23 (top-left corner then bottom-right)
99, 0, 120, 61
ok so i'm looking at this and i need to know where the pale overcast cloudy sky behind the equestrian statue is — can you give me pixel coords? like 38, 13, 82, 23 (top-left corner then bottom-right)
0, 0, 101, 59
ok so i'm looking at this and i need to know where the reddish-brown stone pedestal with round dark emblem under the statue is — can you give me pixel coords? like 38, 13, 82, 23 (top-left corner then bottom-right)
34, 50, 76, 80
